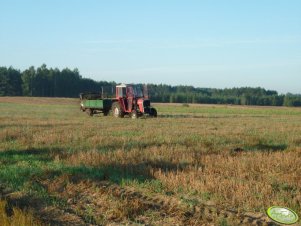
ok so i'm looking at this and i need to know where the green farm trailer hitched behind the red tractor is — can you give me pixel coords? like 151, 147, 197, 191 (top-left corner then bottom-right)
80, 93, 116, 116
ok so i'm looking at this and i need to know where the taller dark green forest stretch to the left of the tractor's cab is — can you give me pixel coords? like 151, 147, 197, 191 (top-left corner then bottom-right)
0, 64, 116, 97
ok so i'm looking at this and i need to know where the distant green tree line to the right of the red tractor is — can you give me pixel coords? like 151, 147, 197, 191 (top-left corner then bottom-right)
148, 84, 301, 106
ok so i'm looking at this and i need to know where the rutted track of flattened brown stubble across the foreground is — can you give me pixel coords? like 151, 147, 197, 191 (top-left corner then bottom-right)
0, 177, 278, 226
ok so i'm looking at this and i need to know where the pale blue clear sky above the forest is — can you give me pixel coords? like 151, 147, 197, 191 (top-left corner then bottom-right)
0, 0, 301, 93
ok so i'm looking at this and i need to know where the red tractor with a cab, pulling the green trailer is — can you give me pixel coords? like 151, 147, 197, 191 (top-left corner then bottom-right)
112, 84, 157, 118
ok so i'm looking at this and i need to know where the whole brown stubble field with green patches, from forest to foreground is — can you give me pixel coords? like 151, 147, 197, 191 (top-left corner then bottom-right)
0, 97, 301, 225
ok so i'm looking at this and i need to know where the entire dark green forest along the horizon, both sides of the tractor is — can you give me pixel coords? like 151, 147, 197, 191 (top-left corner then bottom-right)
0, 64, 301, 106
